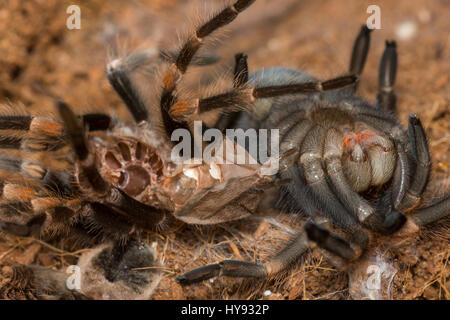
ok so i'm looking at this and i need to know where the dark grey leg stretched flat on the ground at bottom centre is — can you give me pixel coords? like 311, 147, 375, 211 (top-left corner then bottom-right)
177, 230, 309, 285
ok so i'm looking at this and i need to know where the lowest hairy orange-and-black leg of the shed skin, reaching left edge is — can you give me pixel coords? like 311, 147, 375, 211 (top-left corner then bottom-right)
0, 194, 147, 240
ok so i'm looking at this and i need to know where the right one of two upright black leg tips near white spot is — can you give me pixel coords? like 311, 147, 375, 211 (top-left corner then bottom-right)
377, 41, 397, 112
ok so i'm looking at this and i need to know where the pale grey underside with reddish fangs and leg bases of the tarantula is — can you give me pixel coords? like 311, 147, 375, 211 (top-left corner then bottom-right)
265, 99, 396, 193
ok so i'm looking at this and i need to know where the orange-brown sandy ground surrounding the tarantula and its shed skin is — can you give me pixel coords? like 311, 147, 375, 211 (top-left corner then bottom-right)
0, 0, 450, 299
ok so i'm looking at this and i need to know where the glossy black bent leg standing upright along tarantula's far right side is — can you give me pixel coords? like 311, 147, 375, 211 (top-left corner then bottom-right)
398, 115, 431, 210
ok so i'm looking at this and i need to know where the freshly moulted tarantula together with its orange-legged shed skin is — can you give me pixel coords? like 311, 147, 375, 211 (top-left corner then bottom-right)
0, 0, 450, 297
